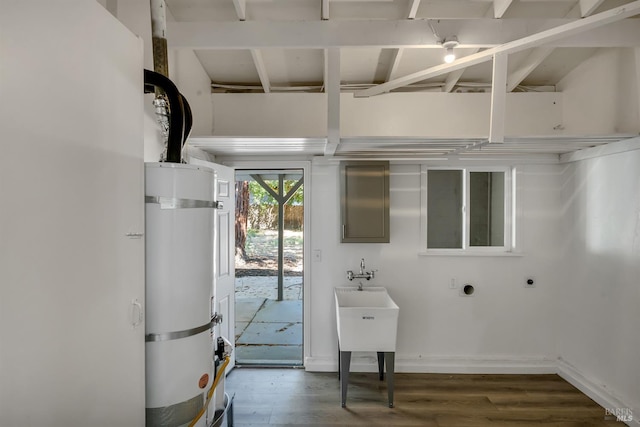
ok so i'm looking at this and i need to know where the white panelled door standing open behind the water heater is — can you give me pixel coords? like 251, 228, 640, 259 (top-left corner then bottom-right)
190, 158, 236, 370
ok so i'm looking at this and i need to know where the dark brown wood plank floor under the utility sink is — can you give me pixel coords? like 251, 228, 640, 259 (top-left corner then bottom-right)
226, 368, 624, 427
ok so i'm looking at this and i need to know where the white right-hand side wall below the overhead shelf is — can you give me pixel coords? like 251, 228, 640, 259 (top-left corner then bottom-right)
557, 145, 640, 417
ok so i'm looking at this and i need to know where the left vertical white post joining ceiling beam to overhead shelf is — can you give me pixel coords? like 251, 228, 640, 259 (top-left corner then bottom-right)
324, 48, 340, 156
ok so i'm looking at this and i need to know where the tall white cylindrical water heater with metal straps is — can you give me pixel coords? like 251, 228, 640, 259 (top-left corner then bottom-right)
145, 163, 217, 426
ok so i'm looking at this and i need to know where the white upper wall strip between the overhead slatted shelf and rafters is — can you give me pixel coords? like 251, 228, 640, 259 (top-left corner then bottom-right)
211, 93, 562, 138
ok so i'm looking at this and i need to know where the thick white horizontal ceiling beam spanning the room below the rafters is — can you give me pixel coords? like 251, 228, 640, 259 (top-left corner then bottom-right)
167, 18, 640, 50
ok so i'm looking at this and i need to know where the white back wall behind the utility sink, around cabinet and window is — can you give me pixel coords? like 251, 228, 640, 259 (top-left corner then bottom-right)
306, 161, 562, 372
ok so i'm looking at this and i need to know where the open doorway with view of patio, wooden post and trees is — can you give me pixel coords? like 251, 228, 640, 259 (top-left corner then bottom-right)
235, 169, 304, 366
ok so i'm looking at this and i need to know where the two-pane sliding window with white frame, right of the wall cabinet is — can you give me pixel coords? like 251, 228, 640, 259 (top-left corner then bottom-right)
422, 167, 514, 253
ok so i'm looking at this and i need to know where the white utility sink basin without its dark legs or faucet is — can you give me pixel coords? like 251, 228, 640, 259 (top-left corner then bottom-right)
334, 286, 399, 351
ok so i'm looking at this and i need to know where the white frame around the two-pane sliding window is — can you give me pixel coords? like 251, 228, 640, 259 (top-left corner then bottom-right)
420, 165, 517, 256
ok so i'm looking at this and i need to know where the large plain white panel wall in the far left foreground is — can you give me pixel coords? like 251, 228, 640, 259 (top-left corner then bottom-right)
0, 0, 144, 427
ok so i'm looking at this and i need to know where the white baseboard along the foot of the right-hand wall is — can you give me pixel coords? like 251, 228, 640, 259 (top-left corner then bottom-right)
557, 358, 640, 426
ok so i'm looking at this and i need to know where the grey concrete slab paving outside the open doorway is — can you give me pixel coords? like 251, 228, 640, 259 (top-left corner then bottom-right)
235, 276, 302, 365
